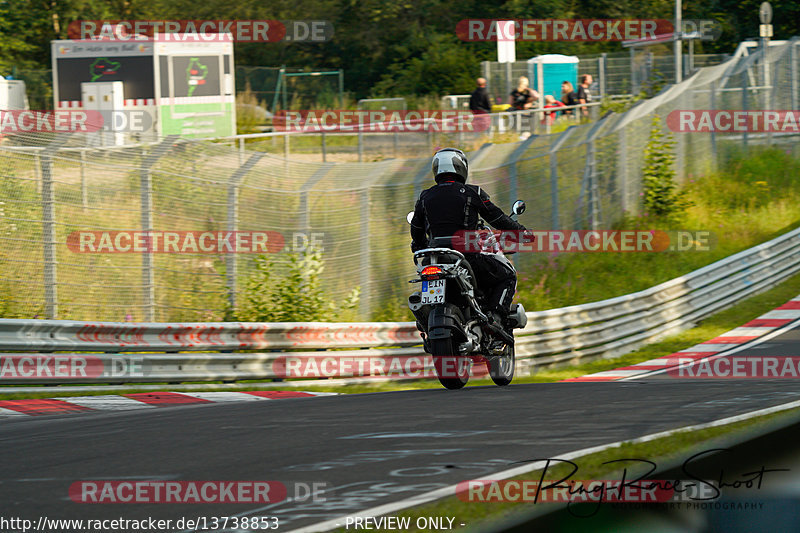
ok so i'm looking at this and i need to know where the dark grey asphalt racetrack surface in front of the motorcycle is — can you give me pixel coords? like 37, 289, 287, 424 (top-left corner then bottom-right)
0, 372, 800, 531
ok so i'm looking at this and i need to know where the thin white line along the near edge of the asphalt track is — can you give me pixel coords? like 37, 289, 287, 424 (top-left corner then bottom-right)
287, 400, 800, 533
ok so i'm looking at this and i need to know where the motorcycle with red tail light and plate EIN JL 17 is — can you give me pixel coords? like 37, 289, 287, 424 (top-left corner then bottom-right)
407, 200, 528, 389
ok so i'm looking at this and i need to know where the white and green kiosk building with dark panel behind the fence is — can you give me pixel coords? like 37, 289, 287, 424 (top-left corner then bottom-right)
51, 34, 236, 144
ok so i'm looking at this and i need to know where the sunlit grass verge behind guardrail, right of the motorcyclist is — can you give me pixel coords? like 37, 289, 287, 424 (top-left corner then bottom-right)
517, 148, 800, 310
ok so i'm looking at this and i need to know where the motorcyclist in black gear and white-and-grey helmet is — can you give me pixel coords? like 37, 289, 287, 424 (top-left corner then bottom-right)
411, 148, 526, 330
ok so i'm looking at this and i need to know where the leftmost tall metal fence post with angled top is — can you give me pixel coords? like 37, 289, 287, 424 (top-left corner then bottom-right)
39, 133, 69, 319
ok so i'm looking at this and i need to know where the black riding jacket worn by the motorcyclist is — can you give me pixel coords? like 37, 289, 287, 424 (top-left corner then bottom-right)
411, 181, 525, 252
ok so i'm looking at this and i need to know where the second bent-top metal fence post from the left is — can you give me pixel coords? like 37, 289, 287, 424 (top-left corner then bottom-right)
139, 135, 178, 322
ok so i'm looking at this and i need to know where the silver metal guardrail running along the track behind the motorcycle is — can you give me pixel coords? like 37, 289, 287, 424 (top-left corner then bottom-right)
0, 224, 800, 384
